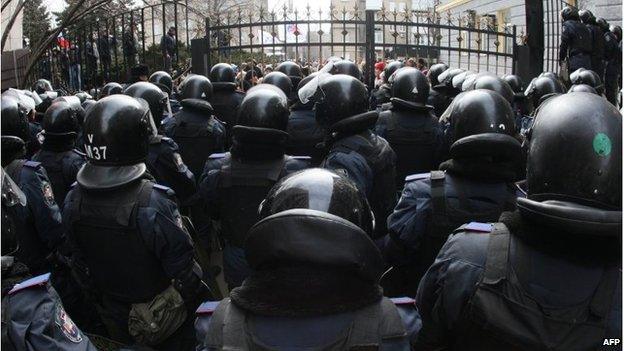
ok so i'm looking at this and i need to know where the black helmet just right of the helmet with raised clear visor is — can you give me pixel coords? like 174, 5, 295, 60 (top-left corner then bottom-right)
391, 67, 429, 105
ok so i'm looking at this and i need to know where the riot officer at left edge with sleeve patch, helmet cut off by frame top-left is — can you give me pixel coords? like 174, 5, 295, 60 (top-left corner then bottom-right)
0, 97, 63, 274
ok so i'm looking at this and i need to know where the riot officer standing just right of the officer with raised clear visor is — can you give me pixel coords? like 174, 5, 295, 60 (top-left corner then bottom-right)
375, 67, 442, 191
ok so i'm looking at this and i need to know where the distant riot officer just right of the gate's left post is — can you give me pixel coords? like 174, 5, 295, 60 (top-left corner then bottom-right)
210, 63, 245, 148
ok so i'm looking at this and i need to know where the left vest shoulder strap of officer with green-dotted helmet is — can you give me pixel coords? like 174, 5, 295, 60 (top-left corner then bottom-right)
483, 223, 511, 284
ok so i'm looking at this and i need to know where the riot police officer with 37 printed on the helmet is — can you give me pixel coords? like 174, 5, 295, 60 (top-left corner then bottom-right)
63, 95, 205, 350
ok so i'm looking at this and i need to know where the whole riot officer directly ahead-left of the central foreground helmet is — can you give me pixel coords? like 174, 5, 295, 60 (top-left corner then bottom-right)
198, 84, 307, 288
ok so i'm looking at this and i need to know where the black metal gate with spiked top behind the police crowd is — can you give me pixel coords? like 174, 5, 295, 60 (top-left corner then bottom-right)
206, 5, 516, 87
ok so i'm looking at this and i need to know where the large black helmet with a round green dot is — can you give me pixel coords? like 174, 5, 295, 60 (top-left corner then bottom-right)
518, 93, 622, 238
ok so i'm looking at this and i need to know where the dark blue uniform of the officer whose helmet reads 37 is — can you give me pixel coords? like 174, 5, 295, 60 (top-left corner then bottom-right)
63, 180, 202, 350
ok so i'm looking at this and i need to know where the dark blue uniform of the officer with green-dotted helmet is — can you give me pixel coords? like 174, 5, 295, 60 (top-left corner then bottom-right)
416, 214, 622, 350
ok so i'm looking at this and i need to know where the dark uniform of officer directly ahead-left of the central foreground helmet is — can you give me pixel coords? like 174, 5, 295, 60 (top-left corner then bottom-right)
197, 153, 309, 288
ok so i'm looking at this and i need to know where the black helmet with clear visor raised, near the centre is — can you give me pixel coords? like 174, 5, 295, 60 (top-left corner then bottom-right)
314, 74, 368, 127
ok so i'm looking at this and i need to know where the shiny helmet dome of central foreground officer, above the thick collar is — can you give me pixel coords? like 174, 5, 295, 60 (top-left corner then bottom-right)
259, 168, 374, 235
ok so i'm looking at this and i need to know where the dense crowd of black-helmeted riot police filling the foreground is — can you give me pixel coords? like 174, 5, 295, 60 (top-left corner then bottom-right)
0, 5, 622, 350
